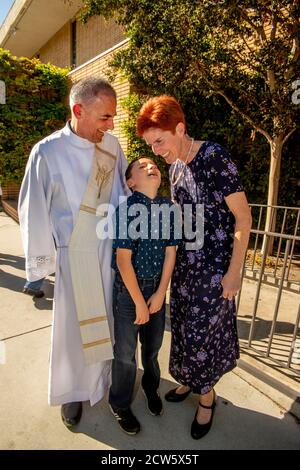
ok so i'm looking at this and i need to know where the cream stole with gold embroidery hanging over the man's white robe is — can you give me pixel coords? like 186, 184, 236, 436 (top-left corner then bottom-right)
69, 143, 117, 365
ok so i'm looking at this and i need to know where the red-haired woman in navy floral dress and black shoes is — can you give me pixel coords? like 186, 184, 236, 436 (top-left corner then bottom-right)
137, 95, 251, 439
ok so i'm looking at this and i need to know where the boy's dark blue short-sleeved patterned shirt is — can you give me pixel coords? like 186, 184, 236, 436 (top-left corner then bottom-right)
112, 191, 179, 279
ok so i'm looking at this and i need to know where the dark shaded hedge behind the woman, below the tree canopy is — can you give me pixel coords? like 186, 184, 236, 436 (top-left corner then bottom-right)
122, 93, 300, 206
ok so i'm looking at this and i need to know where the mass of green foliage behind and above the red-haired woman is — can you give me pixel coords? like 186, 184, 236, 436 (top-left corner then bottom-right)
82, 0, 300, 205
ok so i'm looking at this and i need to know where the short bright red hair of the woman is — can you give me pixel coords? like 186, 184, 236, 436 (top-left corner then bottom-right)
137, 95, 185, 137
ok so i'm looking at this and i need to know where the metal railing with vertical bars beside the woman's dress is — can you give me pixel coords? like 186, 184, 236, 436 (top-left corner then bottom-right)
237, 221, 300, 378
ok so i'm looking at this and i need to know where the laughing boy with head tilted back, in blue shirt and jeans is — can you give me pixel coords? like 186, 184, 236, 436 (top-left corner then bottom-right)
109, 158, 178, 435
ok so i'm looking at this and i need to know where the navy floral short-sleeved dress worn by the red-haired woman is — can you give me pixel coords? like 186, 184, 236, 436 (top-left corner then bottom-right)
169, 141, 243, 395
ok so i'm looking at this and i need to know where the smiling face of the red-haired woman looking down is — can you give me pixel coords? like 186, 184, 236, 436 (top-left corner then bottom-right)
143, 123, 184, 165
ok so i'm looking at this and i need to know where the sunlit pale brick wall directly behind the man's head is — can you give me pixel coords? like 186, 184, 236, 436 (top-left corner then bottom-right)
69, 44, 129, 155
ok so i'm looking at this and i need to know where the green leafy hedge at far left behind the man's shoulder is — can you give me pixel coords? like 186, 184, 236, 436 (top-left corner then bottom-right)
0, 49, 68, 183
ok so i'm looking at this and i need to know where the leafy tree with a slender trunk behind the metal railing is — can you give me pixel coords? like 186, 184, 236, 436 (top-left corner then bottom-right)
82, 0, 300, 239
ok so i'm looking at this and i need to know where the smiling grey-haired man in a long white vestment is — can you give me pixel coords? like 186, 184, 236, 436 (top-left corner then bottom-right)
19, 78, 128, 427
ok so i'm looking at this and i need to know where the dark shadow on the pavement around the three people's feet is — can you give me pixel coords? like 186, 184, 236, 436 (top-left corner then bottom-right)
69, 380, 300, 450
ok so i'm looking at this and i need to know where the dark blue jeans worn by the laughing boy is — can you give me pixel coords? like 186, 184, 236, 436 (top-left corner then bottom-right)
109, 275, 165, 408
